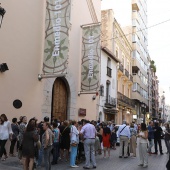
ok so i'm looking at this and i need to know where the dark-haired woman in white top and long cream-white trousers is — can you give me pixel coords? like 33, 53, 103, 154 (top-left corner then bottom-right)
138, 123, 148, 168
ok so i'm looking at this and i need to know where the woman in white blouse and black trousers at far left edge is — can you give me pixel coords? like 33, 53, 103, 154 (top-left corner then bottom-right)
0, 114, 13, 161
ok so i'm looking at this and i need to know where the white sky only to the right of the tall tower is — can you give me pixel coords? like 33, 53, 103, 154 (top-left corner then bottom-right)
147, 0, 170, 105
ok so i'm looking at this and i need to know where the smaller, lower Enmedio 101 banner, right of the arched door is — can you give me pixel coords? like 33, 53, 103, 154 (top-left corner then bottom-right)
81, 25, 101, 91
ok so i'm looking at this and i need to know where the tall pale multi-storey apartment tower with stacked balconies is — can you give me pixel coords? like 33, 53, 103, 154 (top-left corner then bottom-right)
132, 0, 149, 123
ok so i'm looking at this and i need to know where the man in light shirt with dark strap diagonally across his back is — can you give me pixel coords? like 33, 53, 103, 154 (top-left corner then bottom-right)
118, 121, 130, 158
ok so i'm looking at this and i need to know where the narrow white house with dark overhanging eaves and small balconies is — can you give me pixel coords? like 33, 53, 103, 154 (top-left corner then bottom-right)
99, 47, 120, 123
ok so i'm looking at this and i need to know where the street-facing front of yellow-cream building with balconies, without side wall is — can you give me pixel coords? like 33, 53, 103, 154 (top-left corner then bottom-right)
113, 19, 136, 124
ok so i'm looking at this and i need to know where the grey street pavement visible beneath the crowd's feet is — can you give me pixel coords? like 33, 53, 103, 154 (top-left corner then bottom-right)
0, 140, 168, 170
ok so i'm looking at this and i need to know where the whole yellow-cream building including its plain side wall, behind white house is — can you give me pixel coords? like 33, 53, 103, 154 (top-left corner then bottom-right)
102, 10, 135, 124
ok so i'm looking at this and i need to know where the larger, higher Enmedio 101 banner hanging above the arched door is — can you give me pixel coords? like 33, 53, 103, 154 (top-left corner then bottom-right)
43, 0, 71, 74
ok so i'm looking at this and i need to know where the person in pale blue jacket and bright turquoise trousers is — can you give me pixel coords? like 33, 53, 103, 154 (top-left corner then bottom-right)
70, 121, 79, 168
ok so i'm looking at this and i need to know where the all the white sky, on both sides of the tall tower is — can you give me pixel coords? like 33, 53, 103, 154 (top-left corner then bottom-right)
101, 0, 170, 105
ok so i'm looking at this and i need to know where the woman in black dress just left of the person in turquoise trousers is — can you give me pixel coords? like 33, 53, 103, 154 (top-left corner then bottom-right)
59, 121, 70, 161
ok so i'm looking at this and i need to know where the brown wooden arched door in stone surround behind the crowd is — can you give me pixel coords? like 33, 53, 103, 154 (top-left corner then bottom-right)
51, 78, 68, 121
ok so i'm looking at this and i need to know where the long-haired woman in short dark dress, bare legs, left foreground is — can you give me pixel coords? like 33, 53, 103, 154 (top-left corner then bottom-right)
22, 121, 38, 170
